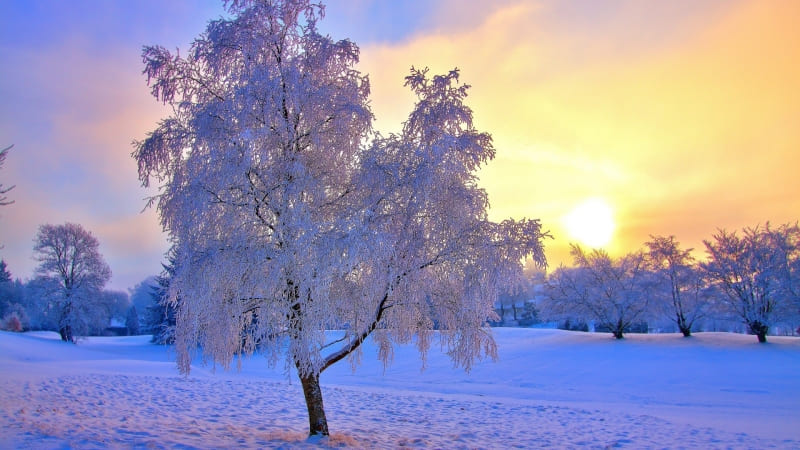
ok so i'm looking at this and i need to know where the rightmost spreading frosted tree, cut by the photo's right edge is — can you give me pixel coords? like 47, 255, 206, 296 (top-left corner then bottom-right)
701, 223, 800, 343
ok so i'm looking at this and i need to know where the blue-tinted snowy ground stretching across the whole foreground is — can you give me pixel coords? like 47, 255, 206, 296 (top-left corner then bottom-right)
0, 329, 800, 448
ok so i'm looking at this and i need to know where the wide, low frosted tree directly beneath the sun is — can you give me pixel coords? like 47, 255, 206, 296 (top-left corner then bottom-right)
543, 245, 652, 339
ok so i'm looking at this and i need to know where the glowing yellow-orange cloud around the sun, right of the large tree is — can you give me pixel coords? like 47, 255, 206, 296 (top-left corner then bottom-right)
354, 1, 800, 266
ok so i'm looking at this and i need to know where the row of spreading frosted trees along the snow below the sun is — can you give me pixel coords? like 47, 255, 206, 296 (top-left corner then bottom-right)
538, 223, 800, 342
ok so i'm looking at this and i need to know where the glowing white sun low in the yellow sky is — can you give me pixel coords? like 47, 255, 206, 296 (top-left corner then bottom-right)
563, 198, 615, 248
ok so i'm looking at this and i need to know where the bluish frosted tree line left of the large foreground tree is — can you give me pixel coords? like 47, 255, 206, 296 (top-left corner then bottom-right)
0, 223, 163, 343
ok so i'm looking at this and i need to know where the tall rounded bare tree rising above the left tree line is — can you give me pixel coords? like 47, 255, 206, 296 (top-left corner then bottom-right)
33, 223, 111, 342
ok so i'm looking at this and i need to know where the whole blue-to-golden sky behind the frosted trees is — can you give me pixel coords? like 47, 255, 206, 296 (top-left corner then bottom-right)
0, 0, 800, 290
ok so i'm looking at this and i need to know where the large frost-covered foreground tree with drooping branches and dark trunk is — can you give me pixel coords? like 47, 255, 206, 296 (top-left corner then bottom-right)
134, 0, 545, 435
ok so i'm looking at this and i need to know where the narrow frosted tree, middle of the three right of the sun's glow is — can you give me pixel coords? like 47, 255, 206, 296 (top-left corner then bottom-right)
645, 236, 714, 337
